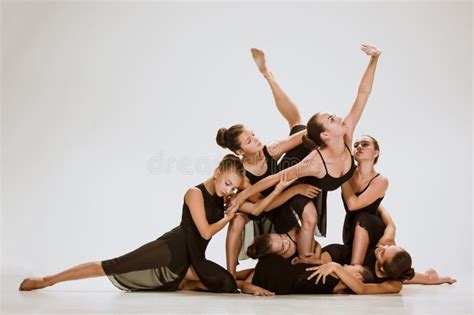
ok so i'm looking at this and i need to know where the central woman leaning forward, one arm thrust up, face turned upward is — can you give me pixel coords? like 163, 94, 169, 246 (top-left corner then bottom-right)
235, 45, 381, 255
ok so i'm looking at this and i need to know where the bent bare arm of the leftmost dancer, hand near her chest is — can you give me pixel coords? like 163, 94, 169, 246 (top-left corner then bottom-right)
184, 187, 237, 240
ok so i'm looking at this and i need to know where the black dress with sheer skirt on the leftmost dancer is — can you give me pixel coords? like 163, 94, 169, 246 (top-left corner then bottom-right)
102, 184, 237, 293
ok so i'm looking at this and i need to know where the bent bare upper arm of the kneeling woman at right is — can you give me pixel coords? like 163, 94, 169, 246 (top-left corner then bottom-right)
341, 175, 388, 211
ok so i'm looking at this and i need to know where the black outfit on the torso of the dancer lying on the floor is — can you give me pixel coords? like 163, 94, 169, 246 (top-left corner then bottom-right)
252, 254, 339, 294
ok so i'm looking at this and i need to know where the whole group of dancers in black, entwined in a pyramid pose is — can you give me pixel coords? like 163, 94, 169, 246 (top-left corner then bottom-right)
19, 45, 456, 296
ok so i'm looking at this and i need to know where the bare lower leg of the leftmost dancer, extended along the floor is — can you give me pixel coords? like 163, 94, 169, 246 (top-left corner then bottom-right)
19, 261, 105, 291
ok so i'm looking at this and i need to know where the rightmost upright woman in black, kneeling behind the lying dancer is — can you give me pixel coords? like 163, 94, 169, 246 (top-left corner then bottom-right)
297, 135, 455, 284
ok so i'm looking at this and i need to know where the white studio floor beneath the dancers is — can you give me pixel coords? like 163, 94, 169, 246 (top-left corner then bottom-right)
0, 276, 473, 315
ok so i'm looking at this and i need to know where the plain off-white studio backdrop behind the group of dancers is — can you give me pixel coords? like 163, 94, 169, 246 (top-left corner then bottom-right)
2, 2, 472, 284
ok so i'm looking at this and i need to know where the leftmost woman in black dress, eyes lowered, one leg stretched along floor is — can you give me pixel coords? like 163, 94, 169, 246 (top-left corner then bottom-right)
19, 154, 245, 293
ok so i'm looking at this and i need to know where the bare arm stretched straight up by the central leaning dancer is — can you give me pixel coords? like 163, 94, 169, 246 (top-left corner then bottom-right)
344, 45, 382, 143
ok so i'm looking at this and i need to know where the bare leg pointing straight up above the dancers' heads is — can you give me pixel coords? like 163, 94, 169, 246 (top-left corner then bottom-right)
251, 48, 302, 129
